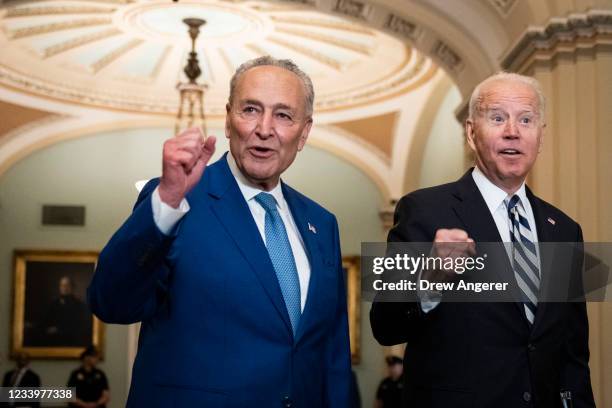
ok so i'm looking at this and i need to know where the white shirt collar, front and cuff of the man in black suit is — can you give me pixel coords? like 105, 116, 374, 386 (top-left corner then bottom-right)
419, 166, 539, 313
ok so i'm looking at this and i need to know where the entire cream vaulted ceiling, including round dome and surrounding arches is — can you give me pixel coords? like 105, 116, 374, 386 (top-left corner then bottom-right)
0, 0, 584, 197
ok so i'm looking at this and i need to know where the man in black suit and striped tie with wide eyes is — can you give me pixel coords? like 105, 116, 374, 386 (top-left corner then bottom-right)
370, 73, 594, 408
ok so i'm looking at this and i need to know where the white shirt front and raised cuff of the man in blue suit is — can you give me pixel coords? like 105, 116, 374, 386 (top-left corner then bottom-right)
151, 153, 310, 312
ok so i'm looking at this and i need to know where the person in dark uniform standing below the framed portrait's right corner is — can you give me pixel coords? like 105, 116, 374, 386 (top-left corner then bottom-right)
68, 346, 110, 408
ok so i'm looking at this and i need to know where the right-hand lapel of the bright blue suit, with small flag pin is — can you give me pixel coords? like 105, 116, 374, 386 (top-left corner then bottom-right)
282, 183, 323, 343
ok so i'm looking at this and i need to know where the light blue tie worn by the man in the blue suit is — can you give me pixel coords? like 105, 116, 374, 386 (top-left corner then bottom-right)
255, 193, 302, 335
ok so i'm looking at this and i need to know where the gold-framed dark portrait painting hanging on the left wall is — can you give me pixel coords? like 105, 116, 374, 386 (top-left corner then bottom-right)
11, 250, 104, 359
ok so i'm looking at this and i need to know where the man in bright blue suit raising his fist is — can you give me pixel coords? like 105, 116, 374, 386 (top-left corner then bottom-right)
88, 57, 351, 408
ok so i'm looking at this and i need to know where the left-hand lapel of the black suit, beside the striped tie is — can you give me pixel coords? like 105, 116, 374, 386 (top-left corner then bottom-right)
454, 170, 528, 326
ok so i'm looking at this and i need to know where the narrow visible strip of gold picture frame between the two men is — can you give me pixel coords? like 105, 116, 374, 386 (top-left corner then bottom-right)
342, 255, 361, 364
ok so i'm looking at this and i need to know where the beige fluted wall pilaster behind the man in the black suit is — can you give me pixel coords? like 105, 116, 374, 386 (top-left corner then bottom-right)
532, 50, 612, 407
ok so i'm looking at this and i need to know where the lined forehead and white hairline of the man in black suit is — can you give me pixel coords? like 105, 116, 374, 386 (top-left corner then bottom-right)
478, 80, 540, 113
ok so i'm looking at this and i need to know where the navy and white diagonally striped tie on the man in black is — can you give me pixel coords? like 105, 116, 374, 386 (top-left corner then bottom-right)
506, 194, 540, 324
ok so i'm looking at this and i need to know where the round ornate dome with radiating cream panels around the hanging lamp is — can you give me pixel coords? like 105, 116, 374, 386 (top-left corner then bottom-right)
0, 0, 436, 115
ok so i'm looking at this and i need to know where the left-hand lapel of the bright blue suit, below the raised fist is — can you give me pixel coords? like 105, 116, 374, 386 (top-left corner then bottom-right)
205, 153, 293, 334
